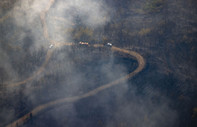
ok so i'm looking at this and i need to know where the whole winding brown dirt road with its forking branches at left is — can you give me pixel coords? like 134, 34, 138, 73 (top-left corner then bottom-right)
0, 0, 145, 127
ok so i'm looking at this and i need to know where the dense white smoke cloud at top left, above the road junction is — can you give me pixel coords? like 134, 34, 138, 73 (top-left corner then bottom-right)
12, 0, 110, 50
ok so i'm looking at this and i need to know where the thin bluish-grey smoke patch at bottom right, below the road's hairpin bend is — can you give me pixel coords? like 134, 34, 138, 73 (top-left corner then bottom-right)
107, 89, 178, 127
